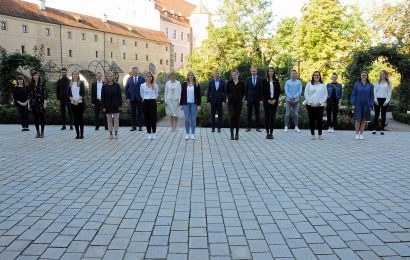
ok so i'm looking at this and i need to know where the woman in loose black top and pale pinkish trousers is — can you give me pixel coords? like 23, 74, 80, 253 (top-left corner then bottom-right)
101, 71, 122, 139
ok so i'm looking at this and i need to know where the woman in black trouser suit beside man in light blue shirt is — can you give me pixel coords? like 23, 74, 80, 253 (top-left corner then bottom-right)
262, 67, 280, 139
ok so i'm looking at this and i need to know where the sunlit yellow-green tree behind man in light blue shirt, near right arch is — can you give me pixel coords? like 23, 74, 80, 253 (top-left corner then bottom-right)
297, 0, 371, 80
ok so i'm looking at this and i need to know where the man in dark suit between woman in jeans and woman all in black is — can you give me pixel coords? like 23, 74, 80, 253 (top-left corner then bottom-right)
207, 70, 226, 133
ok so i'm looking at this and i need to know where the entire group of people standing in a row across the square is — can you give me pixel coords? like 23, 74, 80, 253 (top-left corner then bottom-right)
14, 67, 392, 140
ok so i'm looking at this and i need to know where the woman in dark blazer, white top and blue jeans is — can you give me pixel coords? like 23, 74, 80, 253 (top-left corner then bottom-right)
179, 71, 201, 140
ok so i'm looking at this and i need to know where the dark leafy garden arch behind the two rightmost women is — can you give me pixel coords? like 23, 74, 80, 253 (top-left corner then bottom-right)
344, 45, 410, 112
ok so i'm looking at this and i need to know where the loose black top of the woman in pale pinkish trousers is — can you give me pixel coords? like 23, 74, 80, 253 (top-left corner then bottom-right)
101, 82, 122, 114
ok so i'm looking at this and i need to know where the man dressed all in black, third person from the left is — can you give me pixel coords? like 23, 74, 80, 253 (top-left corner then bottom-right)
56, 68, 73, 130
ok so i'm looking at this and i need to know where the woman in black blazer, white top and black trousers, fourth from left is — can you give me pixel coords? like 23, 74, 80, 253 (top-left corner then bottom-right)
68, 71, 85, 139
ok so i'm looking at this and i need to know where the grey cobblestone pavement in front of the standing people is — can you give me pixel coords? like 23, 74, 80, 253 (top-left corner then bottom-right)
0, 125, 410, 260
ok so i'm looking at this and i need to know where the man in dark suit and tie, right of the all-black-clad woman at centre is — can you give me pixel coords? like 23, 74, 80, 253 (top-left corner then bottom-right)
245, 67, 263, 132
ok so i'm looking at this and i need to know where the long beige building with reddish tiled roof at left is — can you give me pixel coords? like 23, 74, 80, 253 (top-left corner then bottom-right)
0, 0, 174, 82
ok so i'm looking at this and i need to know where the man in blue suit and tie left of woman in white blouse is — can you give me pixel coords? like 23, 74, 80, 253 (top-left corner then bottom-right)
125, 67, 145, 131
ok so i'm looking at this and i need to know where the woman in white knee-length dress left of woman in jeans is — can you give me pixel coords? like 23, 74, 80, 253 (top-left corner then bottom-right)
164, 72, 182, 132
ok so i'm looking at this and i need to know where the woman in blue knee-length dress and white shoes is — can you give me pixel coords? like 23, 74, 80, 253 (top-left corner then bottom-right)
350, 71, 374, 140
